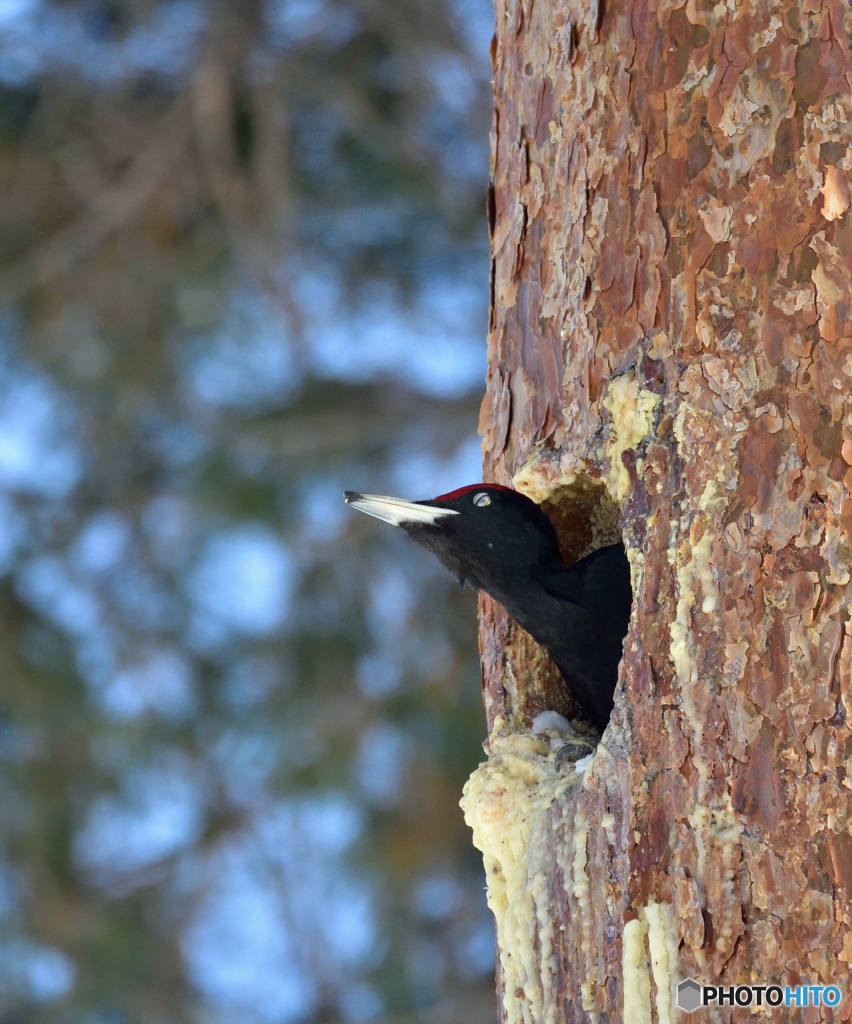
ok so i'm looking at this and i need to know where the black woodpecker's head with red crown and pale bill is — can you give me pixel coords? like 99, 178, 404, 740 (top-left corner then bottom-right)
345, 483, 561, 603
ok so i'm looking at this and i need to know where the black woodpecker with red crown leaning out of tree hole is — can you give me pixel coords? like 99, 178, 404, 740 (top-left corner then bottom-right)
345, 483, 632, 732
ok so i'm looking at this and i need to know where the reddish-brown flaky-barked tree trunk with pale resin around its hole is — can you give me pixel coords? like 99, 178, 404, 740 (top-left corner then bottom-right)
464, 0, 852, 1024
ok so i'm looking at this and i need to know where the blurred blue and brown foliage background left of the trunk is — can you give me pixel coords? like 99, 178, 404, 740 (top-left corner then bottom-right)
0, 0, 495, 1024
